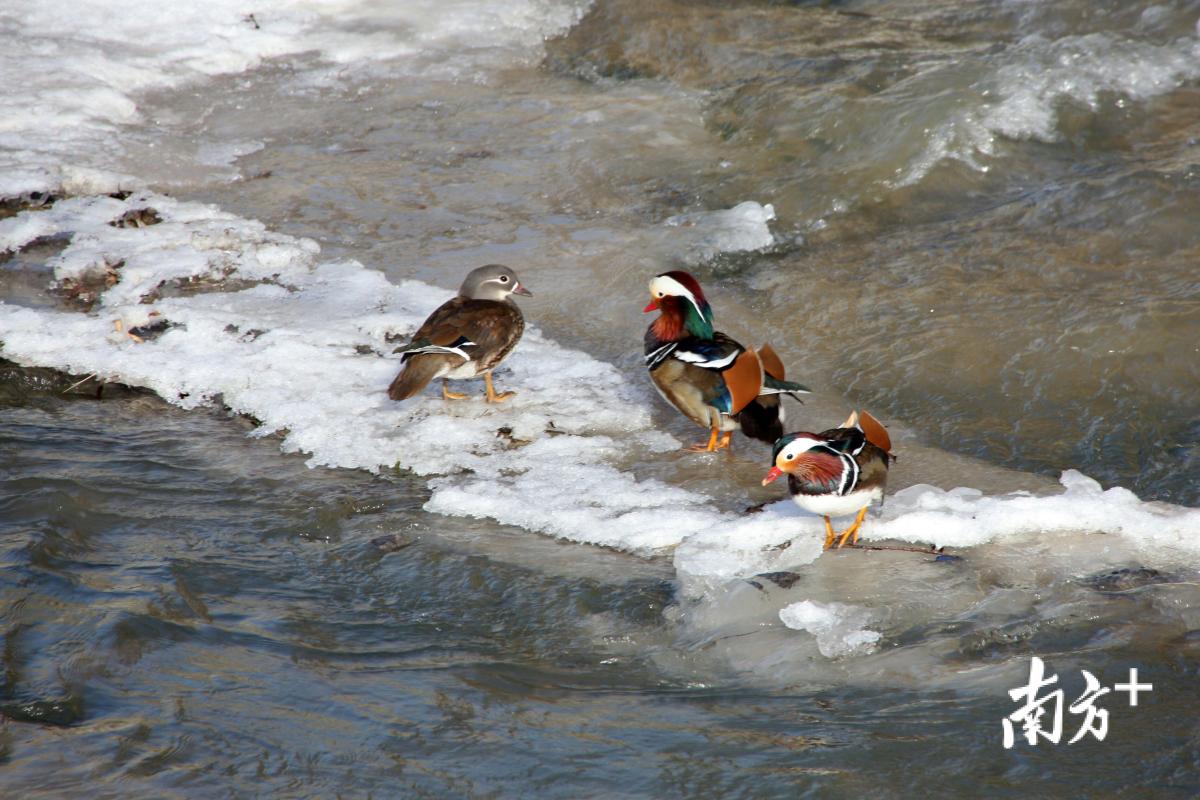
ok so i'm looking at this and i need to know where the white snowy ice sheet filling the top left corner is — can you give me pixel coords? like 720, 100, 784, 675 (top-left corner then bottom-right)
0, 0, 587, 197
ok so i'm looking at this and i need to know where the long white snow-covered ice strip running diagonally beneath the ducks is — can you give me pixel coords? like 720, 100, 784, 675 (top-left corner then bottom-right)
0, 192, 1200, 596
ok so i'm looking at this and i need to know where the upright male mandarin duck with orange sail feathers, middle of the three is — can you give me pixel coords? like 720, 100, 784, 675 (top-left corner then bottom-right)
643, 270, 809, 452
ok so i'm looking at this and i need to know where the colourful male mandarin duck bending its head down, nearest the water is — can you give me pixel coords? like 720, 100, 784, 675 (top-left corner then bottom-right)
762, 411, 895, 549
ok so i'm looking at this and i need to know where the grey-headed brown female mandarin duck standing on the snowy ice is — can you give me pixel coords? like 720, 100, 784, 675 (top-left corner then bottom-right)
388, 264, 533, 403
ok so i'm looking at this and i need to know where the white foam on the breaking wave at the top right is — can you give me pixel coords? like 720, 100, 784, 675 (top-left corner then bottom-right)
898, 34, 1200, 186
